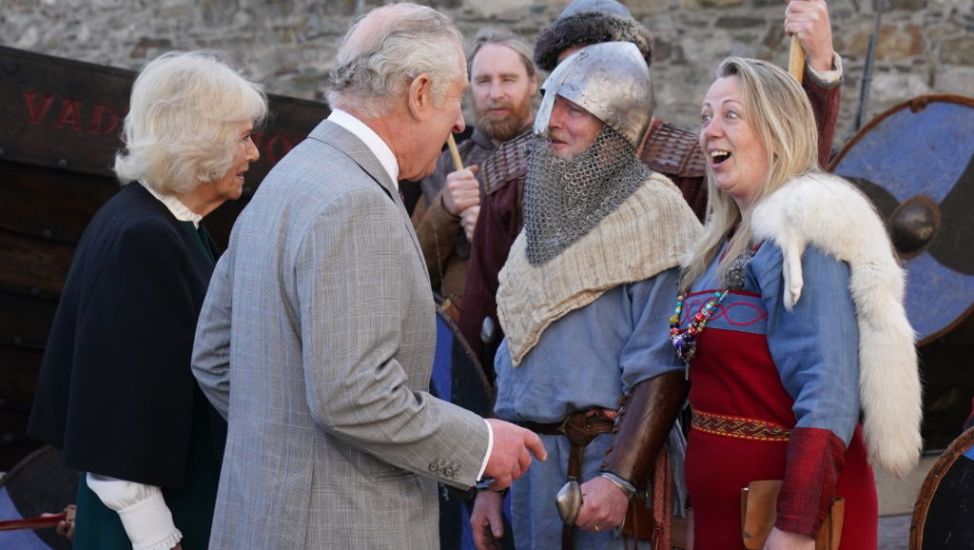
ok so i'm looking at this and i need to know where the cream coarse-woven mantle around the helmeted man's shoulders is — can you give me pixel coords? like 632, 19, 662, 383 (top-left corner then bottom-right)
497, 173, 700, 366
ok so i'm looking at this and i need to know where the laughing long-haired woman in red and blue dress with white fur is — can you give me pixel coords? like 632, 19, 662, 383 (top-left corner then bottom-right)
670, 57, 921, 549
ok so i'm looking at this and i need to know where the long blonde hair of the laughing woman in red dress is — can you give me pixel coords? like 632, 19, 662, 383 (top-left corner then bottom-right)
680, 57, 819, 290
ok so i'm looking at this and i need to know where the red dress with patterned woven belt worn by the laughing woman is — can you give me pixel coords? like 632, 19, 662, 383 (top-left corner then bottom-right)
681, 250, 877, 550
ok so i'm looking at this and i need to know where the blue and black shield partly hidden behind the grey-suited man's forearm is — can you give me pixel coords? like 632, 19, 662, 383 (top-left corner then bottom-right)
430, 308, 514, 550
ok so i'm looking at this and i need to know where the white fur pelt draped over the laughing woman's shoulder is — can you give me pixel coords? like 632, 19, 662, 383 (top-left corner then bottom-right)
751, 173, 923, 478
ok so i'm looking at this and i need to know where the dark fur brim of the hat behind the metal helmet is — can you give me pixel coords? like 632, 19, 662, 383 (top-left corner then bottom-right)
534, 11, 653, 72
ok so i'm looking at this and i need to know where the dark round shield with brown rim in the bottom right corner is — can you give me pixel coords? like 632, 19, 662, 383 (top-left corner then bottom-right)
910, 428, 974, 550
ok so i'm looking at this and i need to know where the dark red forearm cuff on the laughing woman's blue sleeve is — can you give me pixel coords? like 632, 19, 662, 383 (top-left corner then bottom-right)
775, 428, 845, 538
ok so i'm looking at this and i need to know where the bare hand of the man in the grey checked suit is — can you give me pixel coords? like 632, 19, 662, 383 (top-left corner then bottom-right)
484, 418, 548, 491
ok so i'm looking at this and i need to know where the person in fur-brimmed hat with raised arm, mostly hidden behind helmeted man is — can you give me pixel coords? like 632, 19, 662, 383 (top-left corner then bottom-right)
457, 0, 842, 365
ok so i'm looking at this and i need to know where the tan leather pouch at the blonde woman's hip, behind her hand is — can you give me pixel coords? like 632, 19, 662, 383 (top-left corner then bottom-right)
741, 480, 845, 550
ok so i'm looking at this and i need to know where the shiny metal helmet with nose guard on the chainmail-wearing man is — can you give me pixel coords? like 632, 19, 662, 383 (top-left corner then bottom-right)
534, 42, 656, 148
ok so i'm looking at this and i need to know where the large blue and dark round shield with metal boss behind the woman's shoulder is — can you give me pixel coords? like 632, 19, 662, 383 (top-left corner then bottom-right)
831, 95, 974, 346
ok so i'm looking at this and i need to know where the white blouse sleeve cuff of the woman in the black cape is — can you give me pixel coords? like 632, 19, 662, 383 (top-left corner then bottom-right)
86, 473, 183, 550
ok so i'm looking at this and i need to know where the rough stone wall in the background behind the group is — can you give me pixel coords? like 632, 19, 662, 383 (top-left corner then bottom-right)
0, 0, 974, 153
